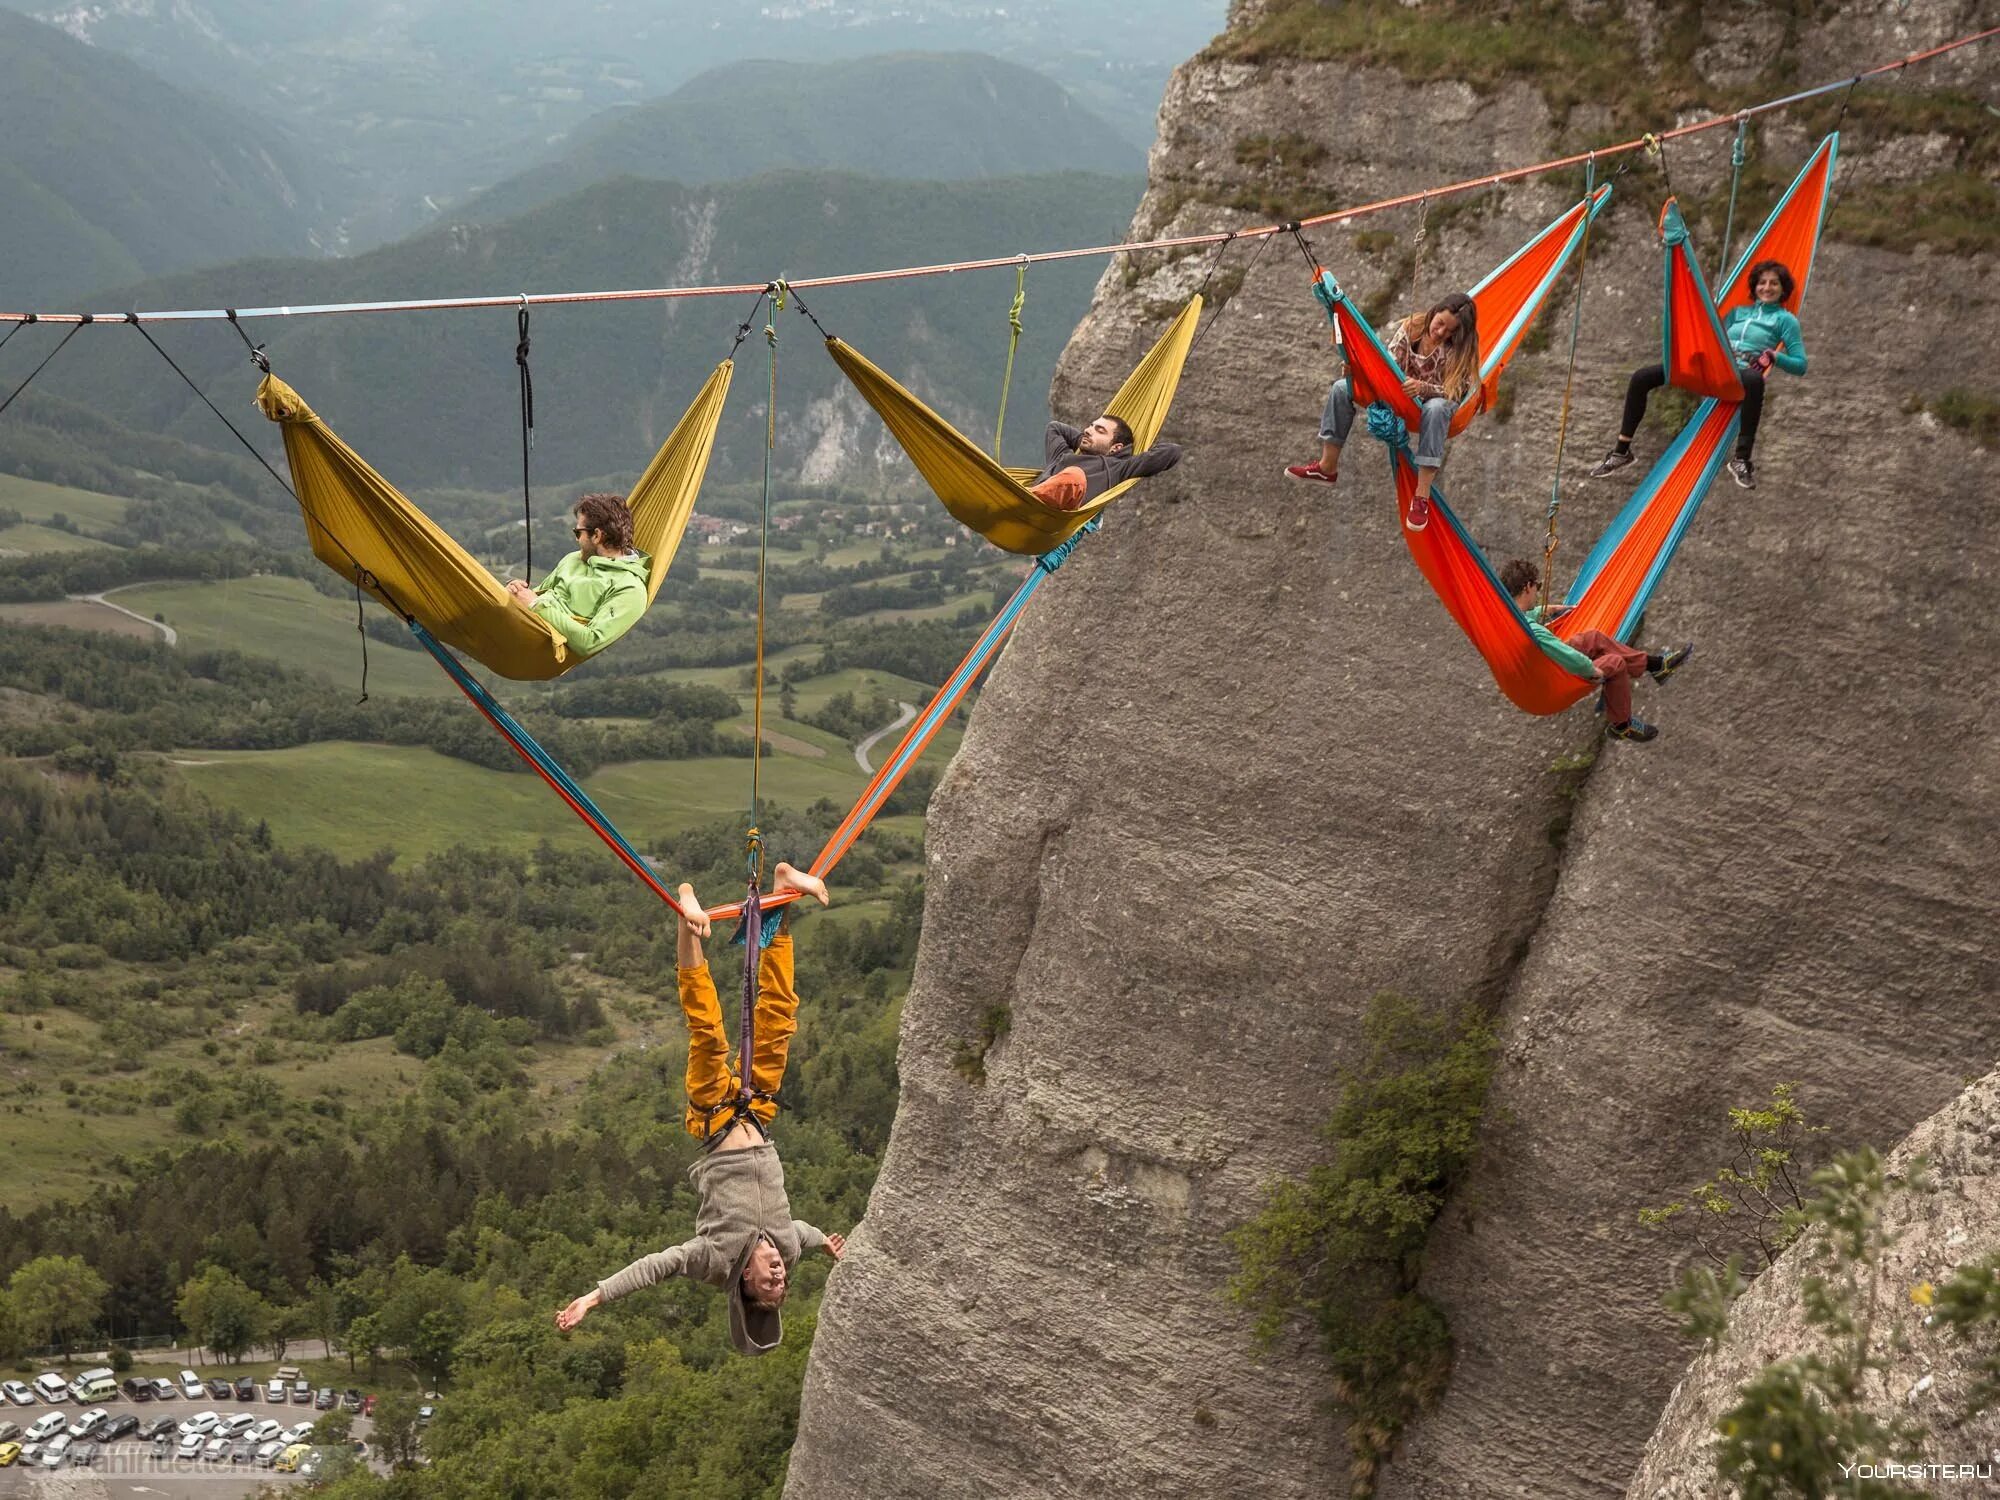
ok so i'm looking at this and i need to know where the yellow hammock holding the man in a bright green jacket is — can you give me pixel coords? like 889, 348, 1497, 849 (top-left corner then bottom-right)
256, 360, 734, 682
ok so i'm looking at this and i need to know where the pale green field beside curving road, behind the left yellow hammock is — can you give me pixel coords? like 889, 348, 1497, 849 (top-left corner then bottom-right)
116, 574, 458, 696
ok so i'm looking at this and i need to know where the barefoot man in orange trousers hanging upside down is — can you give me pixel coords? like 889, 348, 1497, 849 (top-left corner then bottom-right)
556, 864, 846, 1354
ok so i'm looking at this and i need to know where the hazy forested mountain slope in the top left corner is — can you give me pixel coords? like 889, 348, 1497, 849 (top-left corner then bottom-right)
0, 10, 344, 310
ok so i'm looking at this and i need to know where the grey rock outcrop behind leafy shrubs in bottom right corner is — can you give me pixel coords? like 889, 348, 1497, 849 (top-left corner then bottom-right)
1626, 1074, 2000, 1500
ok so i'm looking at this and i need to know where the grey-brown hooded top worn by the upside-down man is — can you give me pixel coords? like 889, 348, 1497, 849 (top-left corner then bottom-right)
598, 1142, 826, 1354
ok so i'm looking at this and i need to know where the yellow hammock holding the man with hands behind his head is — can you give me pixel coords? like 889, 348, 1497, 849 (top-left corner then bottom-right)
826, 296, 1202, 556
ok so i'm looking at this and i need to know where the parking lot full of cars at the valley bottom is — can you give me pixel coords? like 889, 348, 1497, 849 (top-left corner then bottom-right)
0, 1398, 374, 1500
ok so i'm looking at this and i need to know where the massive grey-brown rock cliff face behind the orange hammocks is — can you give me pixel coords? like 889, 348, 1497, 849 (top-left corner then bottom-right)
786, 0, 2000, 1500
